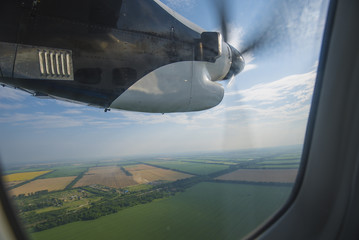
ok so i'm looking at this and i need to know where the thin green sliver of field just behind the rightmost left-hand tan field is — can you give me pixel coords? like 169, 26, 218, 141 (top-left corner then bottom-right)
148, 161, 229, 175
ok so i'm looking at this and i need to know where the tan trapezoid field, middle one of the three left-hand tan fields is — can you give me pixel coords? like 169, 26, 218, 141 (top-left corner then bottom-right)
74, 166, 137, 188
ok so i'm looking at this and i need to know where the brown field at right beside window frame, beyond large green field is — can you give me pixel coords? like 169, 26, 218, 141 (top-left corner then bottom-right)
216, 169, 298, 183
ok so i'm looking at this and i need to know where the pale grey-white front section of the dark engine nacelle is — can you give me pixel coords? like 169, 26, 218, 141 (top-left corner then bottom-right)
110, 61, 224, 113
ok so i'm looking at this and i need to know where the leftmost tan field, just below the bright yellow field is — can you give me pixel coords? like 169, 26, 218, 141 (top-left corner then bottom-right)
10, 176, 76, 196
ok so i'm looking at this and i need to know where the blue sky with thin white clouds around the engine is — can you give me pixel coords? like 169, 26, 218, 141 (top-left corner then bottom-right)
0, 0, 328, 165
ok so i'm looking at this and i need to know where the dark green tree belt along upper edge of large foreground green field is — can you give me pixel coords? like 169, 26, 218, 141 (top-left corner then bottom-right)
25, 176, 208, 232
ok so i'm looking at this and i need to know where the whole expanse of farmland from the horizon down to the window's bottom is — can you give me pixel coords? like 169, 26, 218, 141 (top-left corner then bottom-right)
2, 145, 306, 239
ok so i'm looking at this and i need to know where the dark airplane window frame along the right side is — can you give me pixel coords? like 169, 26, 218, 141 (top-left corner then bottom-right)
250, 0, 359, 237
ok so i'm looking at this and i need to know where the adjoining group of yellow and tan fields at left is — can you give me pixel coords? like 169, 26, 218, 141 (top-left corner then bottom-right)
4, 164, 192, 196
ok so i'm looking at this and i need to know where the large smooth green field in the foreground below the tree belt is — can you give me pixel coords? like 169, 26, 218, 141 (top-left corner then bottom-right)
32, 182, 291, 240
